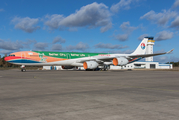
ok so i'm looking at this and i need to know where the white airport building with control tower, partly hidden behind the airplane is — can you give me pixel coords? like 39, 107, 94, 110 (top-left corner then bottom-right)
43, 37, 173, 70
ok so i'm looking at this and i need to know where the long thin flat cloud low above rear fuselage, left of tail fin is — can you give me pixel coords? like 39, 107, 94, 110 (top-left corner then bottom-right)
94, 43, 128, 49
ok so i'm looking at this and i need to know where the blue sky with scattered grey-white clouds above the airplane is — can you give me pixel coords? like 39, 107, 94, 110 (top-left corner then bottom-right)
0, 0, 179, 63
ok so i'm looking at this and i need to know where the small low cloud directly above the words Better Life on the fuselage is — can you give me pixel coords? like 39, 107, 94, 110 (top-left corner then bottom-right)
66, 42, 89, 51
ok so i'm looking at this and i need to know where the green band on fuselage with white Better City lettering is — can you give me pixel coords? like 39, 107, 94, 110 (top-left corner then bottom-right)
33, 51, 108, 59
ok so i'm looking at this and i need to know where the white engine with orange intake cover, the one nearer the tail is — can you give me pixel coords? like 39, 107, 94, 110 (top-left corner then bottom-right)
113, 57, 129, 66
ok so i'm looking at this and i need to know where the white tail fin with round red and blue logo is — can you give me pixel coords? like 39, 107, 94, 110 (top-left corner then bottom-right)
132, 37, 149, 55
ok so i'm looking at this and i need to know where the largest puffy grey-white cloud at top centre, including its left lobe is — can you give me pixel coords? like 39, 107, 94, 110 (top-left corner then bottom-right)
45, 2, 112, 32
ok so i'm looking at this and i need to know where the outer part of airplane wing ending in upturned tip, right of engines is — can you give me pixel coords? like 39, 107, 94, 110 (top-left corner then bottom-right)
128, 49, 174, 58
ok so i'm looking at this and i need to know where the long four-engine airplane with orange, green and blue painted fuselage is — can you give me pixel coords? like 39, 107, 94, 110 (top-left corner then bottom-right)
5, 37, 173, 72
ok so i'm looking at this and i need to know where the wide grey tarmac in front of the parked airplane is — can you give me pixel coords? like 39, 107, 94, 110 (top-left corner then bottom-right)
0, 70, 179, 120
